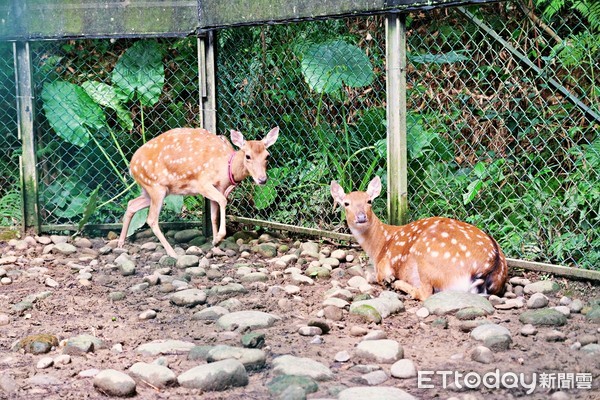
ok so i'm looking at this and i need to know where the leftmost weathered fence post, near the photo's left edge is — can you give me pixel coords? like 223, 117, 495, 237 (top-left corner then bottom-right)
13, 42, 40, 233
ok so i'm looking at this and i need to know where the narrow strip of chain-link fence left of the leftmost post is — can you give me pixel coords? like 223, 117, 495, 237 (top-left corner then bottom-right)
0, 42, 23, 228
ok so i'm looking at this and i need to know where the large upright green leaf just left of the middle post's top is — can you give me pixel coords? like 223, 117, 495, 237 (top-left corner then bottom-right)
112, 40, 165, 106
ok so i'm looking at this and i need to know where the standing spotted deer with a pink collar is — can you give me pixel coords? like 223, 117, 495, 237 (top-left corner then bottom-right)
118, 127, 279, 257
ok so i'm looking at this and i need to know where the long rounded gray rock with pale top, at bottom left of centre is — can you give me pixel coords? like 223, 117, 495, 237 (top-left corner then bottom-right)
177, 359, 248, 392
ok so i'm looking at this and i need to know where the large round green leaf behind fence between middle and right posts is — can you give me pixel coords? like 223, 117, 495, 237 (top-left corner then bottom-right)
301, 40, 374, 93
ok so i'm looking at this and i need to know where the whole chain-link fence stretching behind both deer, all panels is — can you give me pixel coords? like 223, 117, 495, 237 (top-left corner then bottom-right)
0, 2, 600, 268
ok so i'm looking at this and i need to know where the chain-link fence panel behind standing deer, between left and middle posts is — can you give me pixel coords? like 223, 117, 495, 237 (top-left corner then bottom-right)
32, 38, 199, 226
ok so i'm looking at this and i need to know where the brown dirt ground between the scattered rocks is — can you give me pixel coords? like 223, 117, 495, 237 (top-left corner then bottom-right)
0, 228, 600, 400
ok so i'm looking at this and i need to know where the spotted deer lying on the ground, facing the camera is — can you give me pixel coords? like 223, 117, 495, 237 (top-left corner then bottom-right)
331, 177, 508, 300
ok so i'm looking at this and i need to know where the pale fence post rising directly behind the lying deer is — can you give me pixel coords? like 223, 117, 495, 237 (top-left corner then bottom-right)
385, 14, 408, 225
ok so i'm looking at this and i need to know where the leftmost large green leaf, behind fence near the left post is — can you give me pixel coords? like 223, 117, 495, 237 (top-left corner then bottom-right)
42, 81, 106, 147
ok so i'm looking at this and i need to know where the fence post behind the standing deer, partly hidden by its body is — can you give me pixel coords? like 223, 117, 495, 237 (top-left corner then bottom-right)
198, 31, 217, 236
